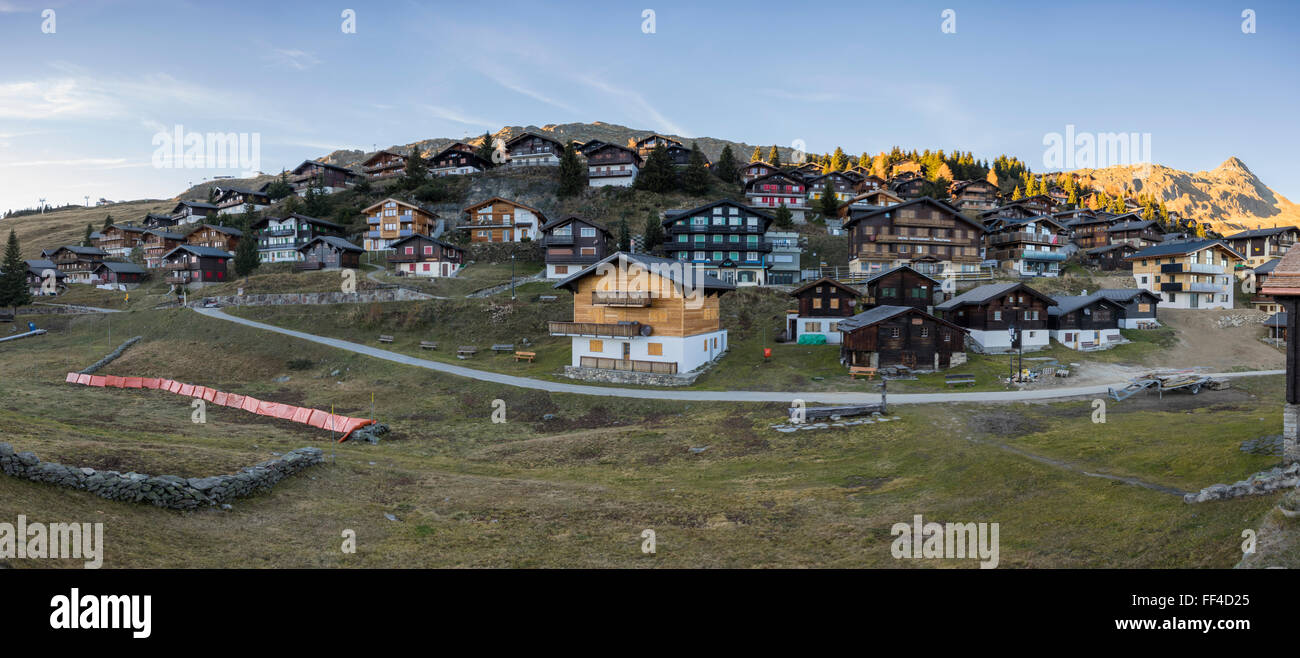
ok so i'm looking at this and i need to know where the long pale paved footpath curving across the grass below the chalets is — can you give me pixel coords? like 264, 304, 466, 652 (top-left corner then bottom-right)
192, 308, 1286, 404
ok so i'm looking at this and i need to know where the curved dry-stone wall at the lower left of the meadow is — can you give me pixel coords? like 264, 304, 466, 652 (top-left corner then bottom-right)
0, 443, 325, 510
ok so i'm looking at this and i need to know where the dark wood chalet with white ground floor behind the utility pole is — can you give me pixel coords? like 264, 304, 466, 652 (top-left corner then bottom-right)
935, 283, 1056, 354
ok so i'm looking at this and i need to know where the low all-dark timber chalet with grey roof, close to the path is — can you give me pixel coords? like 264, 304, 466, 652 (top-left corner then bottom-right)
840, 306, 966, 371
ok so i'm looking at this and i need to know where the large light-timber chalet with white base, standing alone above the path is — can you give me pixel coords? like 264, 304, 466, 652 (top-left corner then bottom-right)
549, 251, 735, 377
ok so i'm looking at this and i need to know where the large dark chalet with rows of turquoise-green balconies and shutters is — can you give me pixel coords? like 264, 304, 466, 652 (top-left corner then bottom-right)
660, 200, 772, 286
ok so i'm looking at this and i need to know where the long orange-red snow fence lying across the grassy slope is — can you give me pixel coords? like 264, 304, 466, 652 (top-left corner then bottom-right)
64, 372, 374, 443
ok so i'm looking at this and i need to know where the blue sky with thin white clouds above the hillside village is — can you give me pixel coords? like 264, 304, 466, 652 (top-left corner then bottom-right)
0, 0, 1300, 212
